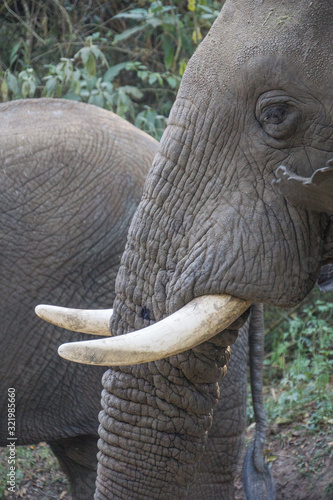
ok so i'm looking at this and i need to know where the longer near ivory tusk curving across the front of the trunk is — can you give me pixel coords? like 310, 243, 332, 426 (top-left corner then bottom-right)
58, 295, 251, 366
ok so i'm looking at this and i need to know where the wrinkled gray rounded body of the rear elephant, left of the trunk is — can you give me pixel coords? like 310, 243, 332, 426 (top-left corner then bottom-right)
0, 99, 158, 500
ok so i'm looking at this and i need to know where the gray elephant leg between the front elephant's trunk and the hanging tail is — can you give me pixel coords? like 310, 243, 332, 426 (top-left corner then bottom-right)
187, 305, 250, 500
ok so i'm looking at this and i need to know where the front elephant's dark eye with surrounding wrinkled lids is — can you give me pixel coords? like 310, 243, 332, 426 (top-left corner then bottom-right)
256, 91, 300, 139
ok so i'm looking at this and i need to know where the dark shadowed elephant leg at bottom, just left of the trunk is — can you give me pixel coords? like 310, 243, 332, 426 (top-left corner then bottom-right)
48, 435, 98, 500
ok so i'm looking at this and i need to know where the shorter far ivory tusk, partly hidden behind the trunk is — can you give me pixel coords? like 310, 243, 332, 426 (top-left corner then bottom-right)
35, 304, 112, 337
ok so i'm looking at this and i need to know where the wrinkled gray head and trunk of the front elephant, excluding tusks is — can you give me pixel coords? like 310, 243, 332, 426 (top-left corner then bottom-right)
95, 0, 333, 500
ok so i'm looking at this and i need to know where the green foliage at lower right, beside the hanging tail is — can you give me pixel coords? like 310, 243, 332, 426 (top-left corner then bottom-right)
265, 293, 333, 428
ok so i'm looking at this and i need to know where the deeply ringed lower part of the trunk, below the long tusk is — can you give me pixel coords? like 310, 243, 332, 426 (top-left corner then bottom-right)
96, 332, 237, 500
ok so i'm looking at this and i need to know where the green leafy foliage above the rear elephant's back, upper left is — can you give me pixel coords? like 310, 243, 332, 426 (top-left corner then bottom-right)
0, 0, 221, 139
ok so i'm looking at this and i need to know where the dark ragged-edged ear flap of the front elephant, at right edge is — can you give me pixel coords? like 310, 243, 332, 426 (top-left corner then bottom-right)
273, 159, 333, 214
